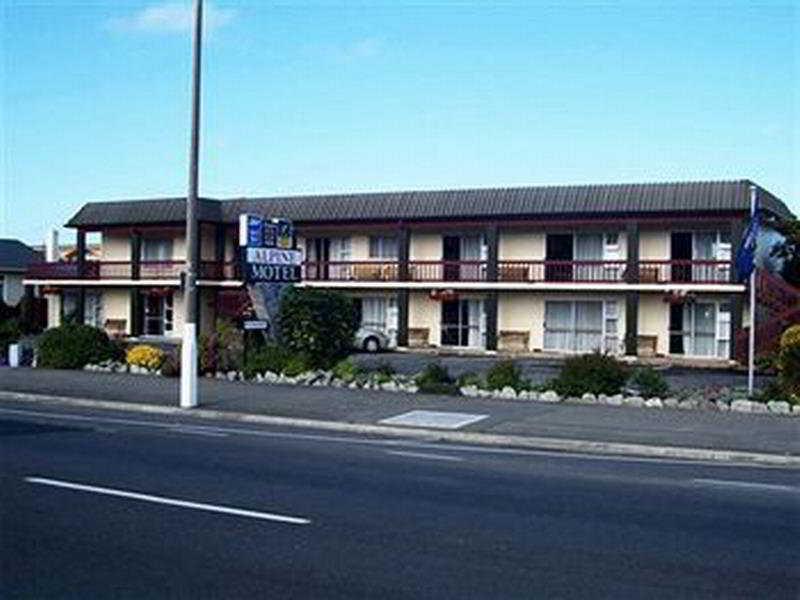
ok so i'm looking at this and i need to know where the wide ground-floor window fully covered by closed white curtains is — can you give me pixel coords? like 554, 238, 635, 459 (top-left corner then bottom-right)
544, 300, 619, 354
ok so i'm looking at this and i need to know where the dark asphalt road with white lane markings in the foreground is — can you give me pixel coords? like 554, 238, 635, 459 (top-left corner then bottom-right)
0, 403, 800, 599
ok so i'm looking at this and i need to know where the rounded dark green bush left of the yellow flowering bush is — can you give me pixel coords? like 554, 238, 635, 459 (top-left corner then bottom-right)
39, 323, 116, 369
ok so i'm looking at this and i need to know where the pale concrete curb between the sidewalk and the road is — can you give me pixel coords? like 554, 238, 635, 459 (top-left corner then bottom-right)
0, 391, 800, 467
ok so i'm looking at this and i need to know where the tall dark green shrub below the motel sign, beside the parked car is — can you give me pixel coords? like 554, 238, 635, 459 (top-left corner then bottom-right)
279, 288, 357, 369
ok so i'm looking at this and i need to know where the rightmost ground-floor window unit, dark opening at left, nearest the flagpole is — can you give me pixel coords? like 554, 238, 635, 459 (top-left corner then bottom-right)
669, 301, 731, 358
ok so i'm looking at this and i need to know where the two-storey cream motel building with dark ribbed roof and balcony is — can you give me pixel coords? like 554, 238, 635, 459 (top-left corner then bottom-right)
25, 181, 791, 362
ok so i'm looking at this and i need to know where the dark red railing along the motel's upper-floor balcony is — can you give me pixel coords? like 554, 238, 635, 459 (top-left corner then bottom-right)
27, 260, 731, 284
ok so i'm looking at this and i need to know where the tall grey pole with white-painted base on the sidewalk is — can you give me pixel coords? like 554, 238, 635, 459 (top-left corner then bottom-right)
180, 0, 203, 408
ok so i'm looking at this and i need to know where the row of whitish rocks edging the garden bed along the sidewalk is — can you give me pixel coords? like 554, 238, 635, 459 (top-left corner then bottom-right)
84, 361, 800, 417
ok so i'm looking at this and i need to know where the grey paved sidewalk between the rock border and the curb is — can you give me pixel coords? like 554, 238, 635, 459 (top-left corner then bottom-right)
0, 369, 800, 457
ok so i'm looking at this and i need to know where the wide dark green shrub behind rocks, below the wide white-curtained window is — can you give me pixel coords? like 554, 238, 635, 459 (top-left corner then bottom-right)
553, 352, 628, 396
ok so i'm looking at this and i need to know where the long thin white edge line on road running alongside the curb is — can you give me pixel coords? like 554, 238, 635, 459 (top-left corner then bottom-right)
0, 408, 783, 470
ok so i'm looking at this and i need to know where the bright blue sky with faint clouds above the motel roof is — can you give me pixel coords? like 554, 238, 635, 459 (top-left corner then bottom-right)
0, 0, 800, 243
